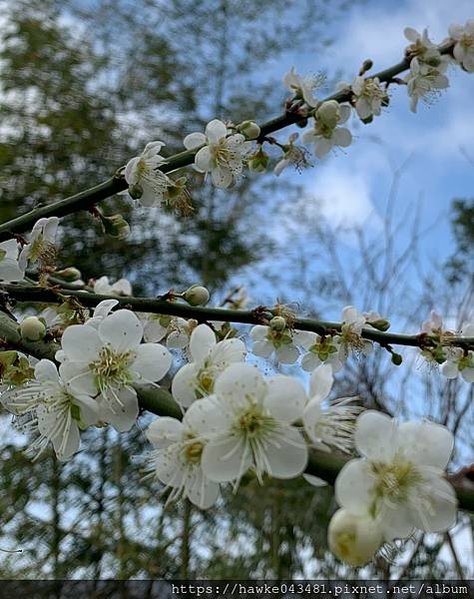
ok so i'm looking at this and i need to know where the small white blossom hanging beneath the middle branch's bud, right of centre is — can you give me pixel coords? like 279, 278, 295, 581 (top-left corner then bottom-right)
250, 324, 313, 364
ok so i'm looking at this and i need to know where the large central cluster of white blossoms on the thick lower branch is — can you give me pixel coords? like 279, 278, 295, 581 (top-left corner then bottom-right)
147, 325, 360, 508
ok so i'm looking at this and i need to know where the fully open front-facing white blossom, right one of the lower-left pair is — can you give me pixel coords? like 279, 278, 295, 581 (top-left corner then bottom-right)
56, 310, 171, 432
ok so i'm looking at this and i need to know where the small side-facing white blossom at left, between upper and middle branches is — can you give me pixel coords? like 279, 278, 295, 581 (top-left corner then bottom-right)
19, 216, 59, 271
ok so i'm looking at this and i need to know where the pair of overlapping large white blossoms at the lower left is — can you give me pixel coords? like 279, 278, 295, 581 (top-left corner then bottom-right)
2, 300, 172, 460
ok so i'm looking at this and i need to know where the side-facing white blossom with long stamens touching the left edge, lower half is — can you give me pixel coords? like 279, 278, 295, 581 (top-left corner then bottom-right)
2, 360, 99, 460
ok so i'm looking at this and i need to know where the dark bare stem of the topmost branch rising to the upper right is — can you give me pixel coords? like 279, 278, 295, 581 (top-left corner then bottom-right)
0, 41, 453, 241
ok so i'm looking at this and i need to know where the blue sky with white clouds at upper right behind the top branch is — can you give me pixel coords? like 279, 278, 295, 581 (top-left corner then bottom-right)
270, 0, 474, 260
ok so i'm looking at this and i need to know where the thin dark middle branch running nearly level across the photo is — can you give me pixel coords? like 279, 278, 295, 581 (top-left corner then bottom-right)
0, 283, 474, 349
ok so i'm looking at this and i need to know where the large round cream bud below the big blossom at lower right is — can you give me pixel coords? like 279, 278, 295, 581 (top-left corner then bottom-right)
328, 509, 383, 566
